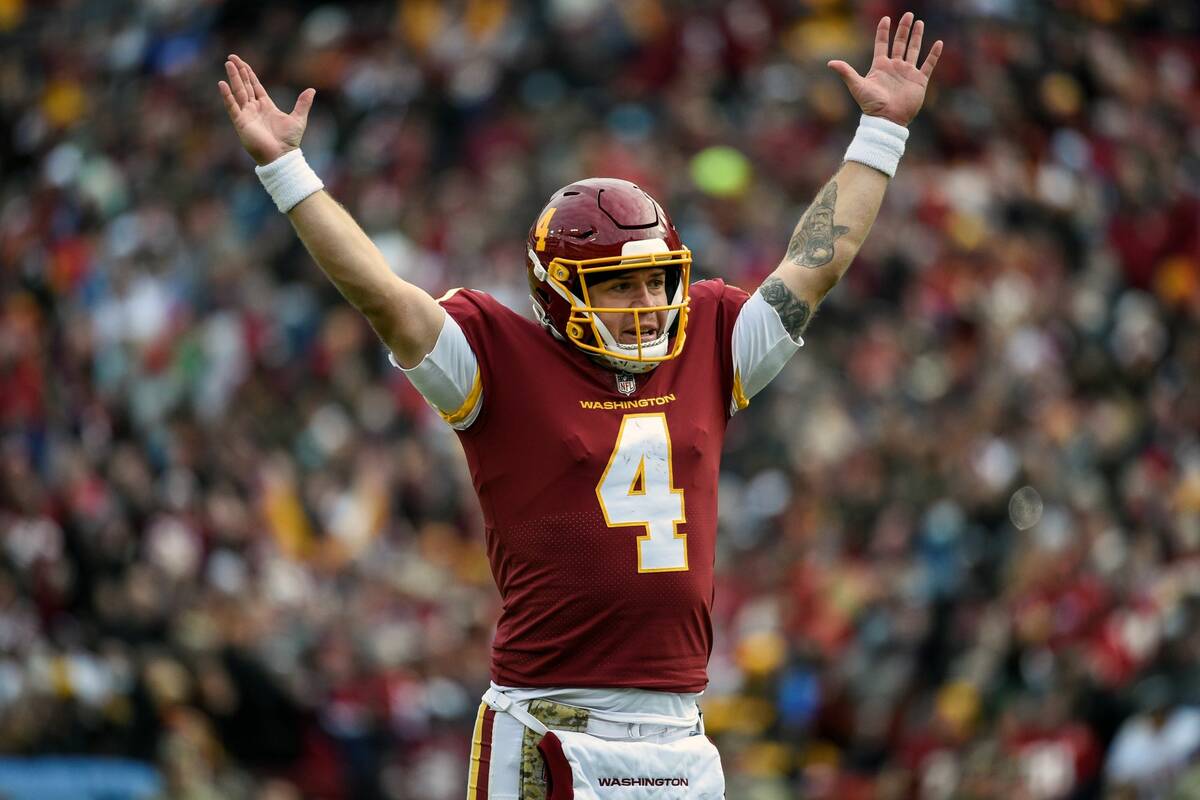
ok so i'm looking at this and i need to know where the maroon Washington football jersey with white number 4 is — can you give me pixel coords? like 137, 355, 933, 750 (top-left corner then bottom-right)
442, 281, 748, 692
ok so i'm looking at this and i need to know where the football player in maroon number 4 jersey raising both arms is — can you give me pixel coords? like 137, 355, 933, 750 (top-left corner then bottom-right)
220, 13, 942, 800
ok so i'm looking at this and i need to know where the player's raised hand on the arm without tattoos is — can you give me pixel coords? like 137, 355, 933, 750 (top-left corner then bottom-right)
217, 55, 317, 164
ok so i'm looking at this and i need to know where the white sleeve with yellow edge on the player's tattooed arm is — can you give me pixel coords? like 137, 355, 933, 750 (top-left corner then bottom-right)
730, 291, 804, 415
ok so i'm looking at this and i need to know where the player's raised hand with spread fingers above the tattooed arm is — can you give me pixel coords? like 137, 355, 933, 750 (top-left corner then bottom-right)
828, 11, 942, 125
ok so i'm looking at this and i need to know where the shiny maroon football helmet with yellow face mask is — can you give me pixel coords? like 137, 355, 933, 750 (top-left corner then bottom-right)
528, 178, 691, 373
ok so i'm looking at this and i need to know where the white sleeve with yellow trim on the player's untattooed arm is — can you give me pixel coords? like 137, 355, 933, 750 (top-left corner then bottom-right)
388, 314, 484, 431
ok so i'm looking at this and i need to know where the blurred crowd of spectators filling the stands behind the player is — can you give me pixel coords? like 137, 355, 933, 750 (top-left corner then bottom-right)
0, 0, 1200, 800
